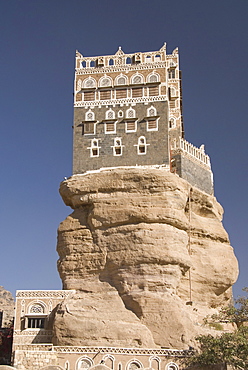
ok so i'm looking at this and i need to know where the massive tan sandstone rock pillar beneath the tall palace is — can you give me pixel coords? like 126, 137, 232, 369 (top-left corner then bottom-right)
54, 168, 238, 349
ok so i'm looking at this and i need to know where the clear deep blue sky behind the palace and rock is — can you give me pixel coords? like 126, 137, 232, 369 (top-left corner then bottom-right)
0, 0, 248, 295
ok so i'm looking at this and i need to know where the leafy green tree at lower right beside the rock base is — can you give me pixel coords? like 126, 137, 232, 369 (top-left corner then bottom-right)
186, 288, 248, 369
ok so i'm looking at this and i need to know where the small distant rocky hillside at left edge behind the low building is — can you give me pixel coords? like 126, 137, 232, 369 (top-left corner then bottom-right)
0, 286, 15, 328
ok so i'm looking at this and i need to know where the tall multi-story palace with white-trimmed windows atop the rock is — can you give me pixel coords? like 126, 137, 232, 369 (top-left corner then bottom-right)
73, 44, 213, 194
